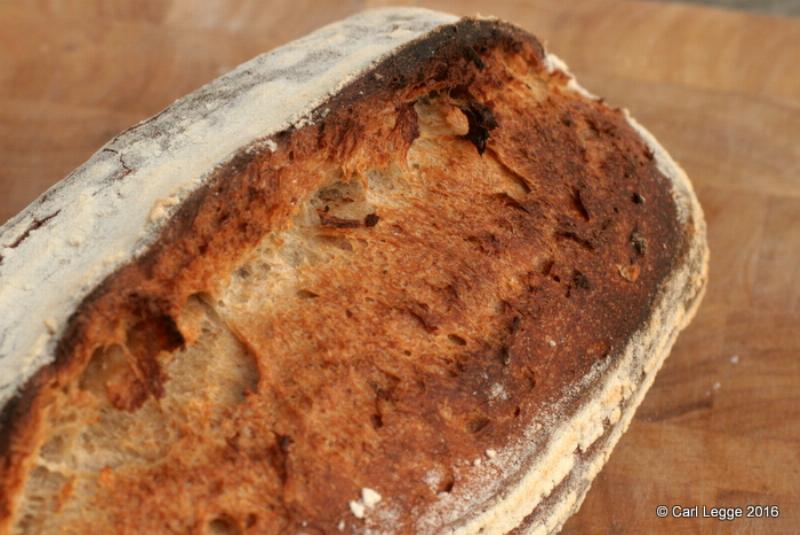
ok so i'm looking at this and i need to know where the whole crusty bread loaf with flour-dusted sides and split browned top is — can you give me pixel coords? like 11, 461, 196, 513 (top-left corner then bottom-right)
0, 9, 708, 534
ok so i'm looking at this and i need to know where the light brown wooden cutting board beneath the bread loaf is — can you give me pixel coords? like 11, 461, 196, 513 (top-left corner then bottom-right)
0, 0, 800, 534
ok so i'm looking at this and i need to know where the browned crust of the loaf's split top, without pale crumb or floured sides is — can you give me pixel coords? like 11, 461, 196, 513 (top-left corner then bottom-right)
0, 20, 684, 532
